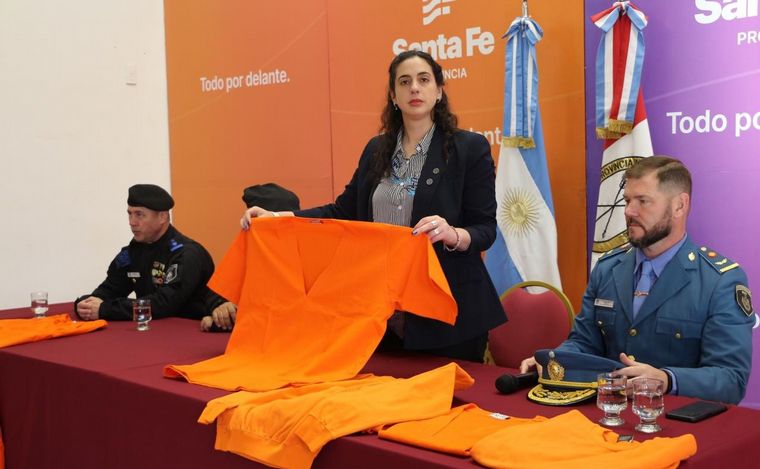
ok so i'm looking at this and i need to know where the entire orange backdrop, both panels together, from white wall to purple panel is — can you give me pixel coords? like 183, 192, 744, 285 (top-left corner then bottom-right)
165, 0, 587, 309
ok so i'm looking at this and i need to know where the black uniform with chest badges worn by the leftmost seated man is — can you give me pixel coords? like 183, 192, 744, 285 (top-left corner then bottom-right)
74, 225, 226, 321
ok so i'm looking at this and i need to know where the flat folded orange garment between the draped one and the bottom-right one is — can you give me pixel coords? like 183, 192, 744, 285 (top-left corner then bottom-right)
378, 404, 546, 456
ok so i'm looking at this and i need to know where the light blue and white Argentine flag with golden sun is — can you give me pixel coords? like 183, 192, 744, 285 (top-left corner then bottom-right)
485, 16, 562, 294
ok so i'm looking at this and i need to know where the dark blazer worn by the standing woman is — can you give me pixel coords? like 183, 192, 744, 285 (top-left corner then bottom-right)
295, 131, 506, 349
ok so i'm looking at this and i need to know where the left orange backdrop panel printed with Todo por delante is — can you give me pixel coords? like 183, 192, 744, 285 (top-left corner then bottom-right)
164, 0, 332, 260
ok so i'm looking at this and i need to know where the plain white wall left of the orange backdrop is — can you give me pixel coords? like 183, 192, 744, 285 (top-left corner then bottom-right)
0, 0, 170, 308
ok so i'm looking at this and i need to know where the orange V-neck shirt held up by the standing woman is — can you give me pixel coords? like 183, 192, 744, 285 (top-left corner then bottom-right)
164, 217, 457, 391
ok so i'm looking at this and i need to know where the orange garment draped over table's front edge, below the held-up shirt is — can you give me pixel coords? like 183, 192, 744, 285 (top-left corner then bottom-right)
199, 363, 474, 469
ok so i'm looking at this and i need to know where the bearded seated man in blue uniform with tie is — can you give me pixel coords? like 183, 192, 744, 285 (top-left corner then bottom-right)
520, 156, 755, 404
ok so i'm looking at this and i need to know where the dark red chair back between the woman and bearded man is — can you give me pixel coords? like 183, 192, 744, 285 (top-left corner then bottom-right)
488, 281, 575, 368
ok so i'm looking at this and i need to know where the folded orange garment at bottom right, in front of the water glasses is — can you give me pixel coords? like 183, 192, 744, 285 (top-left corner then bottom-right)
471, 410, 697, 469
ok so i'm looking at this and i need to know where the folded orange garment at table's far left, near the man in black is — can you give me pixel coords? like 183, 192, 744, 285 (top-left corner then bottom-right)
0, 313, 108, 348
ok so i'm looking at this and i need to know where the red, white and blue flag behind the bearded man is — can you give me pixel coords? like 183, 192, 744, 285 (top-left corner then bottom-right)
591, 2, 653, 269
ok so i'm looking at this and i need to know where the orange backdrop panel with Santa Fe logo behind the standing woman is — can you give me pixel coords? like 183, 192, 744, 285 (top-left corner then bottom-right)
327, 0, 587, 310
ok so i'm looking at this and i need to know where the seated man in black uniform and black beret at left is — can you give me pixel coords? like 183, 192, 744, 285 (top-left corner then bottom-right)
74, 184, 226, 321
